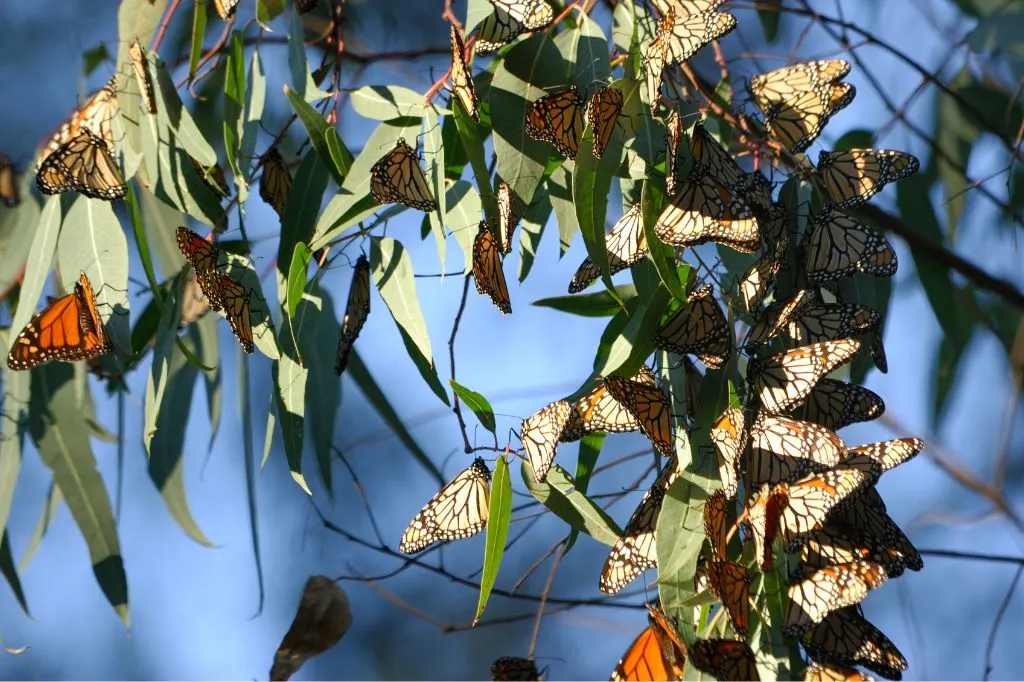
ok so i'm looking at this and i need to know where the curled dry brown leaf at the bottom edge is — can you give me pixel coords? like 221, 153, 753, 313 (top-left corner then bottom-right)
270, 576, 352, 681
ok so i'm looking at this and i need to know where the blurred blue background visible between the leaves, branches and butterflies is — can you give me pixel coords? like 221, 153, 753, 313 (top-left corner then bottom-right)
0, 0, 1024, 679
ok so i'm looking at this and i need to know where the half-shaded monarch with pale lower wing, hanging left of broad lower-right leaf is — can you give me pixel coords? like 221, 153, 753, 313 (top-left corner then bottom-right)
598, 457, 679, 594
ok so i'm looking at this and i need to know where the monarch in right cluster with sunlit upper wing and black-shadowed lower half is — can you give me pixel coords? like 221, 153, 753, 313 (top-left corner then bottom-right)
749, 414, 847, 485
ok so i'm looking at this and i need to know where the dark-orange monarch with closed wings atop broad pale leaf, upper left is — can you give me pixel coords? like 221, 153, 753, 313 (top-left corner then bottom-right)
36, 128, 128, 202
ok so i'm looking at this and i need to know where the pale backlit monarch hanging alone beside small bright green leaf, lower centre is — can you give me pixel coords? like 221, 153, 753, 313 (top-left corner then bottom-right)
398, 458, 490, 554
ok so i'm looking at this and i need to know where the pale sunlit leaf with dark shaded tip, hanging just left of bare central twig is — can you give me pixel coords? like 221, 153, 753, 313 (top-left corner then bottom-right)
370, 237, 450, 404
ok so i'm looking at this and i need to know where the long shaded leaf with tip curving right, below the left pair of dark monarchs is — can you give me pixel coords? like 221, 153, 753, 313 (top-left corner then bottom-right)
146, 324, 213, 547
